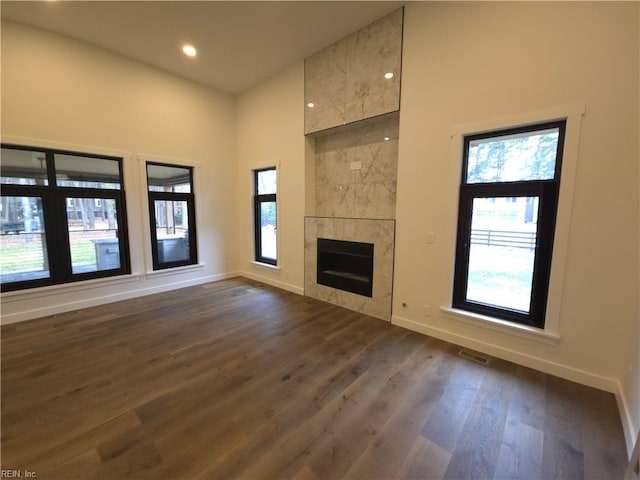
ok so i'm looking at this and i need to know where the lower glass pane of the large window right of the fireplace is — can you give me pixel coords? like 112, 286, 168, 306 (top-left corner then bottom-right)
467, 197, 538, 313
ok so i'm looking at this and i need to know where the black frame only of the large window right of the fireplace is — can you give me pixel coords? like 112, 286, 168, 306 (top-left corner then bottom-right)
452, 119, 567, 329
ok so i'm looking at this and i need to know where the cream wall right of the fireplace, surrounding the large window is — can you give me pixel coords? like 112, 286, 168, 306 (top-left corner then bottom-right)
394, 2, 640, 454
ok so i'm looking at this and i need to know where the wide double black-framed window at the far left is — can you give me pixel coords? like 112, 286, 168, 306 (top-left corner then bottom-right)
0, 145, 131, 291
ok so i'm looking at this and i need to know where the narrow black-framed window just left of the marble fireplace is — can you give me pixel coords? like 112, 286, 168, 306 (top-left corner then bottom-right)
253, 167, 278, 265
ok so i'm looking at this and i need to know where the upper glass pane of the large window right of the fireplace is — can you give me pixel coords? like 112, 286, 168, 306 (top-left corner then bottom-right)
467, 128, 559, 183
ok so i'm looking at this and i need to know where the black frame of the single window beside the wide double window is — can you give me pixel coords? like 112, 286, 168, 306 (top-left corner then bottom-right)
145, 161, 198, 271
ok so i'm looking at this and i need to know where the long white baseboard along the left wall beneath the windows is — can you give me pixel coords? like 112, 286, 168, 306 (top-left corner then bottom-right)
0, 272, 238, 325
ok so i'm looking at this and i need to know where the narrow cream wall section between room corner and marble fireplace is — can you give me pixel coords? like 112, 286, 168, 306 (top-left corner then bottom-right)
235, 62, 305, 294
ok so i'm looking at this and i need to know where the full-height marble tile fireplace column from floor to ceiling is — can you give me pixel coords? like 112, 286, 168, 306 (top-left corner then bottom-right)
304, 9, 403, 321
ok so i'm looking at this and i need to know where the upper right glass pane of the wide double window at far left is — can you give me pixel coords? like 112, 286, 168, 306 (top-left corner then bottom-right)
55, 153, 120, 190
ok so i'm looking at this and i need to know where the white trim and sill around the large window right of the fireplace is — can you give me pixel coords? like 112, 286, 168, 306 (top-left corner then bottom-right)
442, 104, 585, 343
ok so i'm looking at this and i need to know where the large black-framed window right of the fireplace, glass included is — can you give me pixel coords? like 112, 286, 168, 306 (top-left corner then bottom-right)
452, 121, 566, 328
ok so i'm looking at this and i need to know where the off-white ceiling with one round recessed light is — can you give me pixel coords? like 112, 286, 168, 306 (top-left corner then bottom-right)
0, 0, 406, 94
